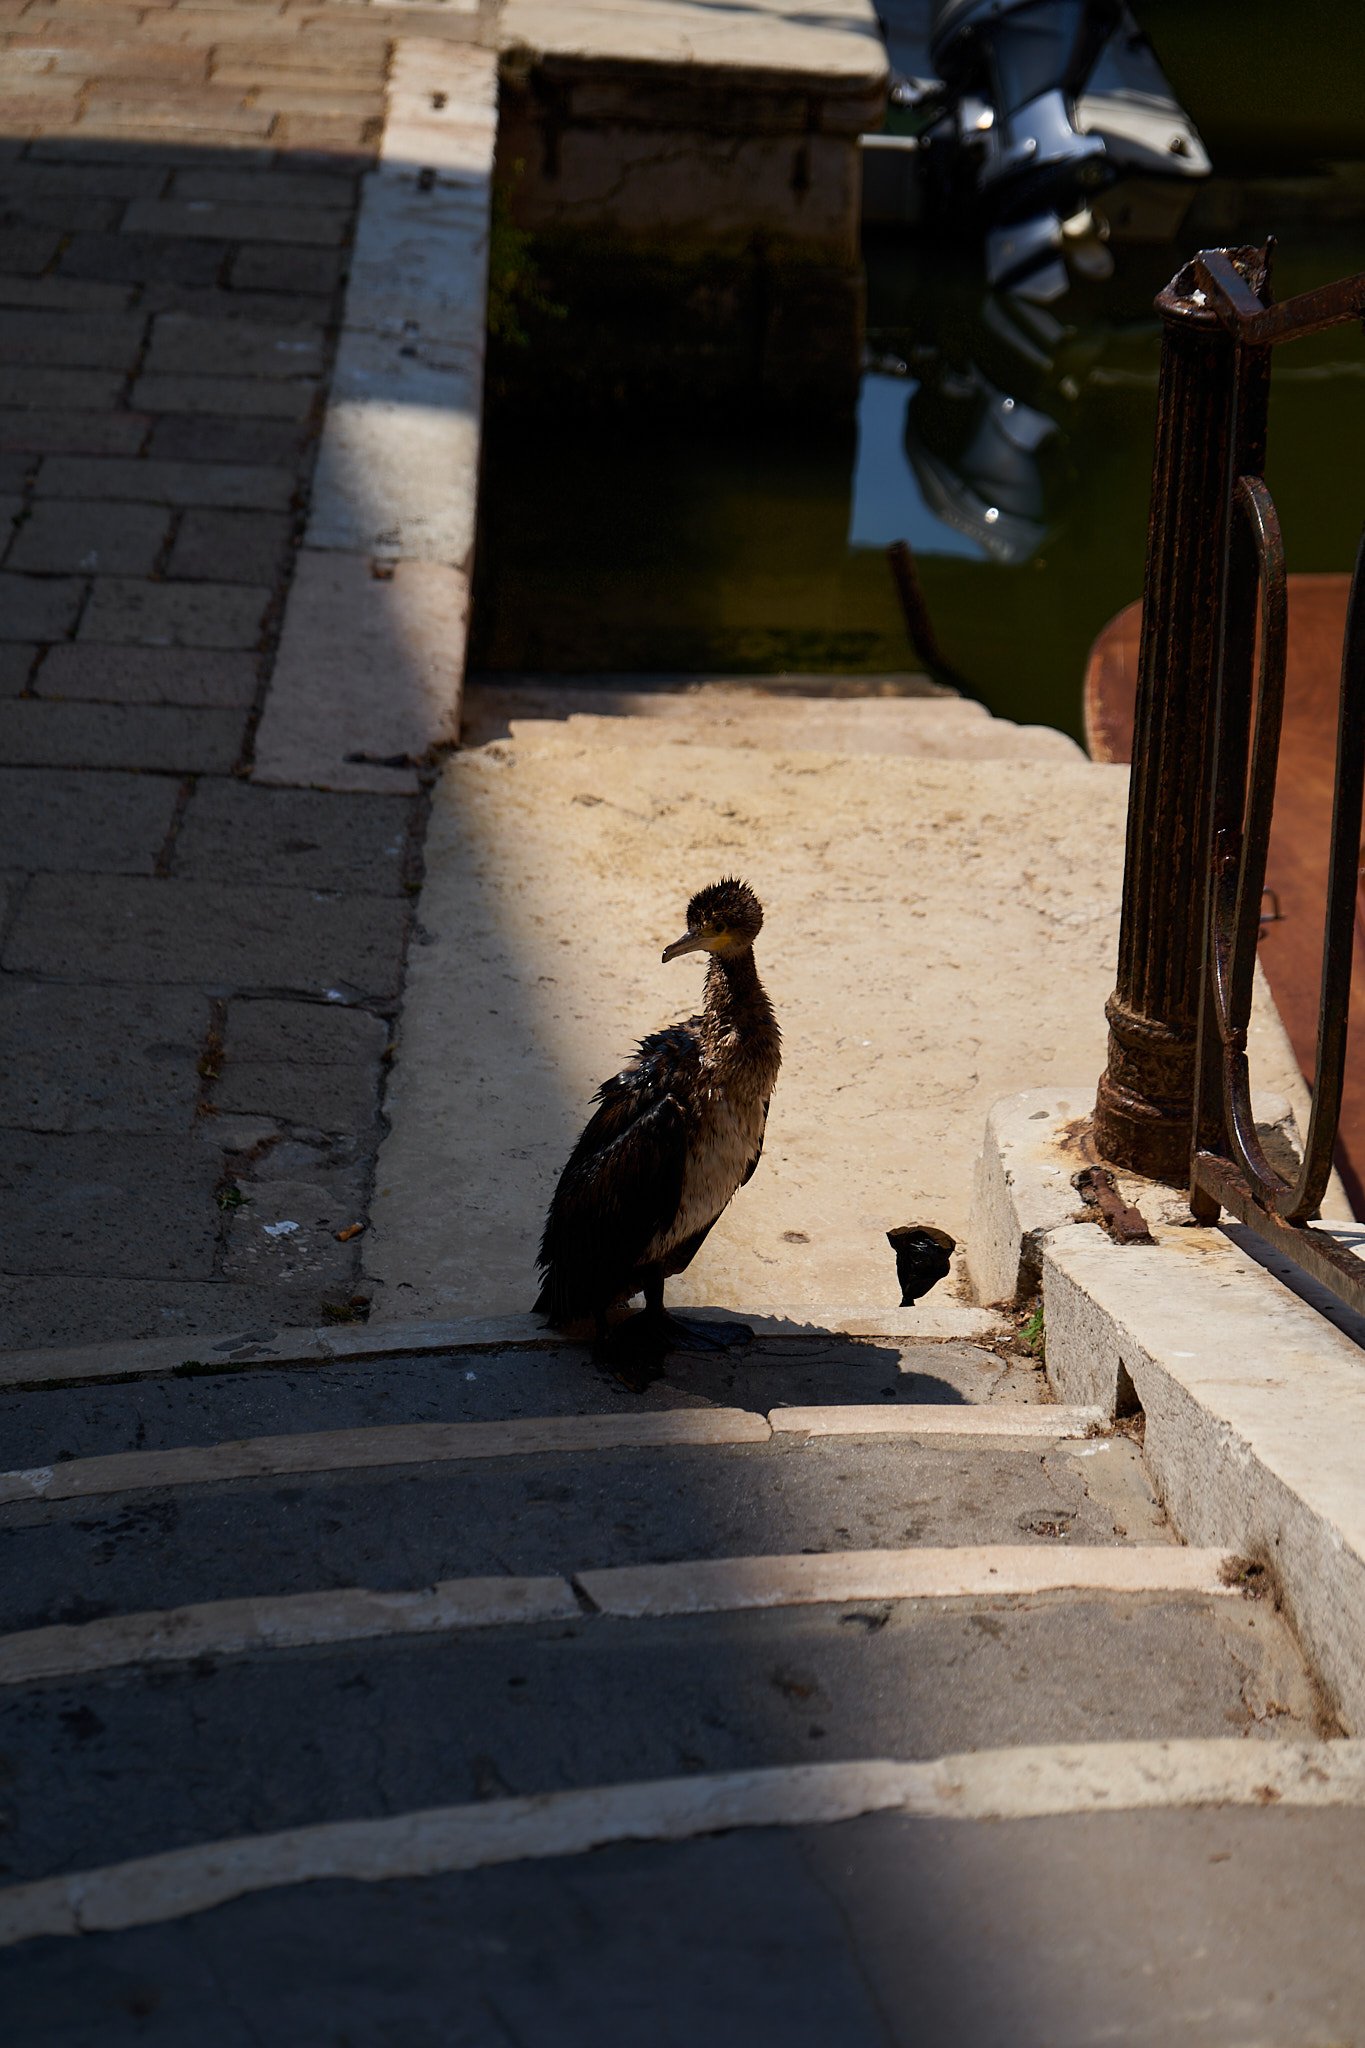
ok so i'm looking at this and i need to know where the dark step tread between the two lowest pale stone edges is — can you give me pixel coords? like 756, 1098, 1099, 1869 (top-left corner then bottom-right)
0, 1589, 1316, 1882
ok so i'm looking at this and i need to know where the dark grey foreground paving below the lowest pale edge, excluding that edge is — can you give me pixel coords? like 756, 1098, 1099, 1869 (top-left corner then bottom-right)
0, 1802, 1365, 2048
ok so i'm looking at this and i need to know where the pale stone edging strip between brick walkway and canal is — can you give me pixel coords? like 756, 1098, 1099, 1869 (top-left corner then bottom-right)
252, 37, 497, 795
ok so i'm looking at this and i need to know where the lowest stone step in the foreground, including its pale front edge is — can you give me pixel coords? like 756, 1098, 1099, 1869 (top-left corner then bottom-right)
0, 1739, 1365, 2048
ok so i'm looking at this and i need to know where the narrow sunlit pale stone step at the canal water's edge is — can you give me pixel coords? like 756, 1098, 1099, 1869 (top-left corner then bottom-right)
463, 682, 1085, 762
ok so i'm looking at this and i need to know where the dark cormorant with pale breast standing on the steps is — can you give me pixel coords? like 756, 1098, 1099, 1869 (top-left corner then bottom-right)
536, 881, 782, 1380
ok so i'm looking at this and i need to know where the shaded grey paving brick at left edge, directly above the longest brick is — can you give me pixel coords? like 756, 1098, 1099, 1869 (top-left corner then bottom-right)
0, 761, 180, 874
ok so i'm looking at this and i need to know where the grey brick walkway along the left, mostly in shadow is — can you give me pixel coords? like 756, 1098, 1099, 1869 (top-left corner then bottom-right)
0, 0, 491, 1346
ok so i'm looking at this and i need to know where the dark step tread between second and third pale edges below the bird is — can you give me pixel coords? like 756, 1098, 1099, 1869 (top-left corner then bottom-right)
0, 1409, 1179, 1630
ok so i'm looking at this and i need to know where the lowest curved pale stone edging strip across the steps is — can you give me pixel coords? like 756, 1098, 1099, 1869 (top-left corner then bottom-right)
0, 1737, 1365, 1948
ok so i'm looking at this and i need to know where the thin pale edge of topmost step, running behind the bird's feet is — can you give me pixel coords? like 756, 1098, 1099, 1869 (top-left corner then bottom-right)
0, 1305, 1003, 1391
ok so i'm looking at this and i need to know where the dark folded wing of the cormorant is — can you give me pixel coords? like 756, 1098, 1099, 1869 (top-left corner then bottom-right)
540, 1024, 700, 1319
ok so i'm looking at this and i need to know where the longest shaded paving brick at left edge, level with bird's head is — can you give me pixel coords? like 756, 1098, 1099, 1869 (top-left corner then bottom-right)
4, 874, 405, 1001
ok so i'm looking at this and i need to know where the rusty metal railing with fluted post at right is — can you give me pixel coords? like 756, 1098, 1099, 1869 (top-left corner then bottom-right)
1095, 246, 1365, 1311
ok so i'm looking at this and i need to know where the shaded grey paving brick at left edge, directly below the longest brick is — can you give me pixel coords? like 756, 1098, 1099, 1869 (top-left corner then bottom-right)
0, 975, 209, 1133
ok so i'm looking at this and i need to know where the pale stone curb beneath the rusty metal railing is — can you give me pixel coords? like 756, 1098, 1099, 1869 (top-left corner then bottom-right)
972, 1092, 1365, 1729
